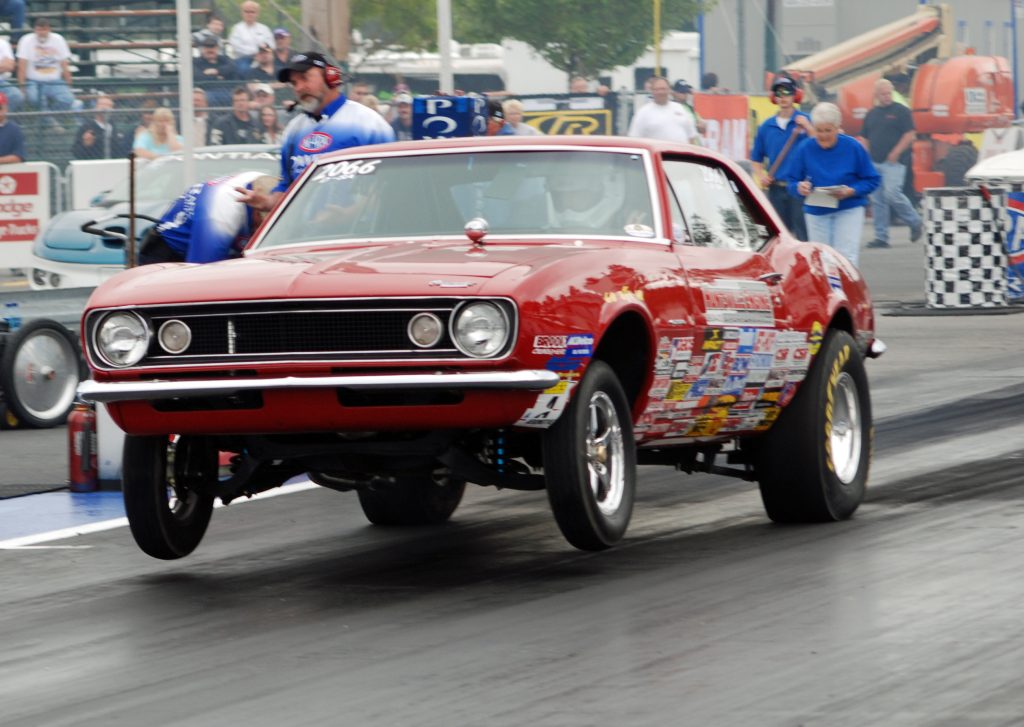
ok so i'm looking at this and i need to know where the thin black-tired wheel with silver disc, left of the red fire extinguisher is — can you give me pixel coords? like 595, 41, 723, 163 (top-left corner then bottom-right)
0, 318, 81, 428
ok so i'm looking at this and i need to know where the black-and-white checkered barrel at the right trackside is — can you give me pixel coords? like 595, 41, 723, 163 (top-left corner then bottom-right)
924, 187, 1008, 308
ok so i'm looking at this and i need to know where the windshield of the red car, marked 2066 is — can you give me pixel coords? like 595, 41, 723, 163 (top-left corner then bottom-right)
258, 149, 656, 248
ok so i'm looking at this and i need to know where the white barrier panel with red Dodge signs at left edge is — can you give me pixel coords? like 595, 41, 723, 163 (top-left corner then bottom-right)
0, 162, 63, 267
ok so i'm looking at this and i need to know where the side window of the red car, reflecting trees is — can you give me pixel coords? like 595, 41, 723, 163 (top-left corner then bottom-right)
664, 159, 763, 250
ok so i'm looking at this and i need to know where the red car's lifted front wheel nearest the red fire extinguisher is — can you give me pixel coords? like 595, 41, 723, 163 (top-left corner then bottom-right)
122, 435, 217, 560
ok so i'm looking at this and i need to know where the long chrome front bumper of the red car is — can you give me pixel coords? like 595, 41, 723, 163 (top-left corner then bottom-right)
78, 370, 559, 402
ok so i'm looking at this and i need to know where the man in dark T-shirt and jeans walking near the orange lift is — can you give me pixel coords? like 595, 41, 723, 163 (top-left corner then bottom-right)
860, 78, 924, 248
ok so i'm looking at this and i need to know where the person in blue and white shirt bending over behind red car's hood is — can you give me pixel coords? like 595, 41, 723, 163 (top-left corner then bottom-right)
138, 172, 278, 265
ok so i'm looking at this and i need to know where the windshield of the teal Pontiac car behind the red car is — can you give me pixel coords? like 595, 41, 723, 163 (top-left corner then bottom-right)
100, 149, 281, 206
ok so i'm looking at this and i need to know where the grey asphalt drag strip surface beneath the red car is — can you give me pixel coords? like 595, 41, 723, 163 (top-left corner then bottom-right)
0, 237, 1024, 725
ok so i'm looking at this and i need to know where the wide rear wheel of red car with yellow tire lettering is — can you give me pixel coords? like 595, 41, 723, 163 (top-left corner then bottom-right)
754, 330, 872, 522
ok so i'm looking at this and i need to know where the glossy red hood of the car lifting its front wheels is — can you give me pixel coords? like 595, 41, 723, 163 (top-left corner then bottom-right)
89, 241, 608, 307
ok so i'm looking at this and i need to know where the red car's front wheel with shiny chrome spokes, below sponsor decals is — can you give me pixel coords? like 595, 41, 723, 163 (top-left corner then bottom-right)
544, 360, 636, 550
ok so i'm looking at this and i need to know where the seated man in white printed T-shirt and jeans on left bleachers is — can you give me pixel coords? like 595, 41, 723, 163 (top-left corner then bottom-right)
17, 17, 80, 126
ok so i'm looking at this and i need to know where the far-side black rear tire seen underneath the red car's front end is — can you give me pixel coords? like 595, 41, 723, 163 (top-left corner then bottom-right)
356, 476, 466, 525
